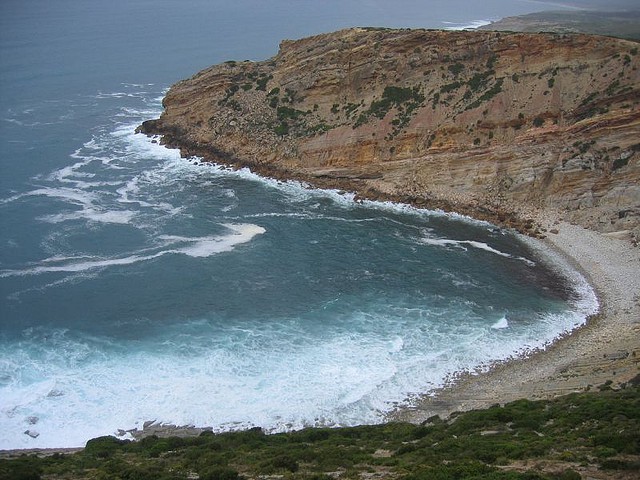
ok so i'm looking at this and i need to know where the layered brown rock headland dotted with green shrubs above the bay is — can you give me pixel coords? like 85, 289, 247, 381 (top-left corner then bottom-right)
140, 29, 640, 238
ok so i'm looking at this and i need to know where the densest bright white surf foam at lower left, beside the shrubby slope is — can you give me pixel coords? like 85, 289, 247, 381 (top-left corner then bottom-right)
0, 324, 394, 448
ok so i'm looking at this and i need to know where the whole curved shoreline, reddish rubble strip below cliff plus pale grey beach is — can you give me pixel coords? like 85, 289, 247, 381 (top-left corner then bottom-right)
0, 135, 640, 458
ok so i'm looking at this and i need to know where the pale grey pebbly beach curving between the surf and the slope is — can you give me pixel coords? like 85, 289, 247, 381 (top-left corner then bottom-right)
392, 214, 640, 423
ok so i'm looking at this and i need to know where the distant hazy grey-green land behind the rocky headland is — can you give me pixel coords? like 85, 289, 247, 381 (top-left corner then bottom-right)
479, 4, 640, 40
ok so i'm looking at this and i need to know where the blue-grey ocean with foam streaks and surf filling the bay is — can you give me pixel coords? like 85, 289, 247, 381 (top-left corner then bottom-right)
0, 0, 597, 449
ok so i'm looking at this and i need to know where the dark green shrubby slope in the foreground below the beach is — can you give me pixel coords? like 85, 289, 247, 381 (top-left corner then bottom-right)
0, 382, 640, 480
